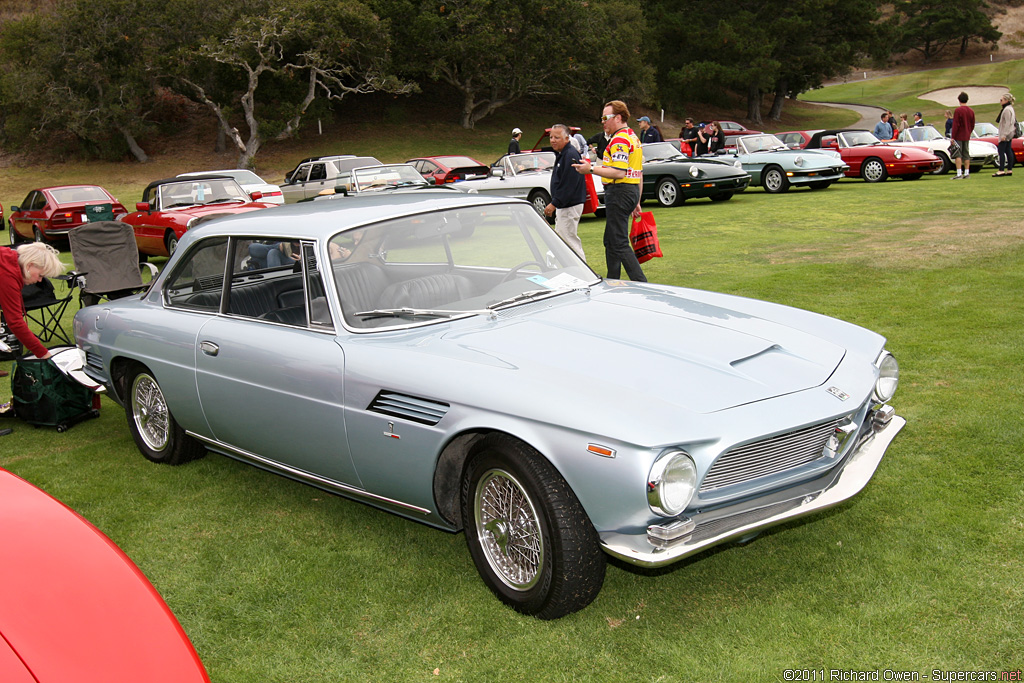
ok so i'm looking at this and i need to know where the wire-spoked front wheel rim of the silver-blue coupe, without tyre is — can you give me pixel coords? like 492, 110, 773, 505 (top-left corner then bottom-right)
473, 469, 545, 591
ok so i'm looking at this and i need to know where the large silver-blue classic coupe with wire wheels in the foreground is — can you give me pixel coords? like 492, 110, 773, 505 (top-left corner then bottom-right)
75, 190, 904, 618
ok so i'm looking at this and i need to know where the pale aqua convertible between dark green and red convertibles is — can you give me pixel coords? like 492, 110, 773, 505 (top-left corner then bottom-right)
727, 133, 850, 194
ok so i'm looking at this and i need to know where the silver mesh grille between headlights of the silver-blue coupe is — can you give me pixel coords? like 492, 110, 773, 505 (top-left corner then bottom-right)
700, 418, 844, 492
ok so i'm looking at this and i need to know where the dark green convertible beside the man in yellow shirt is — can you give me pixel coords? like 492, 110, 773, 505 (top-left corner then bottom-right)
641, 142, 751, 206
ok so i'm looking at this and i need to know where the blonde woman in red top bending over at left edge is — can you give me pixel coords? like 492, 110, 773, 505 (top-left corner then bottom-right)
0, 242, 65, 387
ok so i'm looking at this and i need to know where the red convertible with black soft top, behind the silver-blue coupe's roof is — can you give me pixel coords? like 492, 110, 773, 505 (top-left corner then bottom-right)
121, 175, 278, 257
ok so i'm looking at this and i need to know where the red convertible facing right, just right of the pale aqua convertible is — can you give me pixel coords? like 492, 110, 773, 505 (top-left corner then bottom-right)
775, 129, 942, 182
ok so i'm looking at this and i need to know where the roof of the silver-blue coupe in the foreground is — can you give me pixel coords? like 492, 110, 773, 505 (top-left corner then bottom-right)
184, 188, 526, 245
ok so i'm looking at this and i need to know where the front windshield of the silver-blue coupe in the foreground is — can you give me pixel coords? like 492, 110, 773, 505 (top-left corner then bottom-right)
328, 203, 599, 330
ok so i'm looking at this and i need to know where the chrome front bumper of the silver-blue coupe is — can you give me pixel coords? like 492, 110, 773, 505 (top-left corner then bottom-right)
600, 416, 906, 567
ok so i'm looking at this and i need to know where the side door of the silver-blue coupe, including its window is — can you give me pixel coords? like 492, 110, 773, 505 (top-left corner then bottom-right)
196, 238, 359, 486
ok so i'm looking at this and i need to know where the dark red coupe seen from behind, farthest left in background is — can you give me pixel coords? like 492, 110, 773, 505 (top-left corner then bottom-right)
7, 185, 128, 245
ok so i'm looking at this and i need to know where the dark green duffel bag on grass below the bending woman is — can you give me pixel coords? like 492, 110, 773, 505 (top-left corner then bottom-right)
10, 355, 99, 432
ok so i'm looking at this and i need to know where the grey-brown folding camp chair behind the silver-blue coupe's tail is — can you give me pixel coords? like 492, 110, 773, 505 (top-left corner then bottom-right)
68, 220, 157, 306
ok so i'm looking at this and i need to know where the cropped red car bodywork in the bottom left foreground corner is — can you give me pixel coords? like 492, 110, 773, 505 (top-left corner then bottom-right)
0, 470, 210, 683
